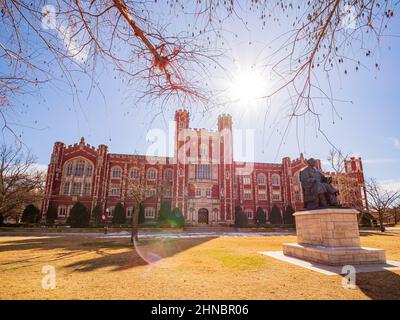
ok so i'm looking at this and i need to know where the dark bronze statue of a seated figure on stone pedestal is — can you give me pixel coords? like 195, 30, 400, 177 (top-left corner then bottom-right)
300, 158, 339, 210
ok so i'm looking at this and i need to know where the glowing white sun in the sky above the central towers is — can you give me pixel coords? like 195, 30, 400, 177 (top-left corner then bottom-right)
229, 68, 267, 103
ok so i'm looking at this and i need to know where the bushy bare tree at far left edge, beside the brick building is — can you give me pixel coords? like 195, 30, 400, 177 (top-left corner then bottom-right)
0, 145, 45, 219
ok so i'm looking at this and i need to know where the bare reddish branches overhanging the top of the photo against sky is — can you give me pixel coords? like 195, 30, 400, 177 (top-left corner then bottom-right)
0, 0, 400, 140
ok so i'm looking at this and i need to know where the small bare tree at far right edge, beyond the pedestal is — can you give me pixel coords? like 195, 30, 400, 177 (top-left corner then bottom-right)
366, 179, 400, 232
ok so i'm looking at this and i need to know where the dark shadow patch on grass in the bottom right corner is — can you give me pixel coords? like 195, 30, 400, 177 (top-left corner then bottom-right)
356, 271, 400, 300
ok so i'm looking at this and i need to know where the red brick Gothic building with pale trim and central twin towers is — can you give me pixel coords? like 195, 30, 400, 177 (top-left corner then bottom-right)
42, 110, 365, 224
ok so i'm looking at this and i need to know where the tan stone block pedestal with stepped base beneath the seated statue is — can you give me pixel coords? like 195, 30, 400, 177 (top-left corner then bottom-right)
283, 208, 386, 265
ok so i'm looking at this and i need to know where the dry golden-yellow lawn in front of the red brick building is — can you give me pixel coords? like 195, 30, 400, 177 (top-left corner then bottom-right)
0, 232, 400, 299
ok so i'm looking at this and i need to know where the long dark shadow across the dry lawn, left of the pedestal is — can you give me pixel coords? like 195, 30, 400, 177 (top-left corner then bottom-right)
0, 237, 215, 272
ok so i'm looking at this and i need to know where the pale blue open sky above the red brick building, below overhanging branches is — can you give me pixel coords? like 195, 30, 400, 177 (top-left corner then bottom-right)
0, 3, 400, 190
